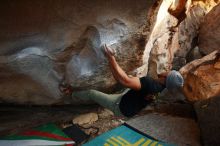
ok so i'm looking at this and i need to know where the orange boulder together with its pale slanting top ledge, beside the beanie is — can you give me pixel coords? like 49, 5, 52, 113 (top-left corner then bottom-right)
180, 52, 220, 101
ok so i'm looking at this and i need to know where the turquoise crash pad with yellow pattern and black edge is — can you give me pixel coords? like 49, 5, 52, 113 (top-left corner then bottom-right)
83, 124, 174, 146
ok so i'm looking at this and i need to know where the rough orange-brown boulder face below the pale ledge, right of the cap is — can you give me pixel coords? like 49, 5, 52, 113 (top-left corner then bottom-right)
184, 59, 220, 101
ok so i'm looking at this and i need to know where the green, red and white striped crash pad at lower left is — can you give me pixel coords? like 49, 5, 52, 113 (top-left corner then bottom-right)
0, 123, 75, 146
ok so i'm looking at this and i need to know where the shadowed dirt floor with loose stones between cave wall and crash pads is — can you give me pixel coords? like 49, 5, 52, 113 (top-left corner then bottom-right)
0, 98, 195, 145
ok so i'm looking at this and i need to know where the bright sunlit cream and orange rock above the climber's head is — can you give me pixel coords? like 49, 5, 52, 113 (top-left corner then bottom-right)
143, 0, 219, 78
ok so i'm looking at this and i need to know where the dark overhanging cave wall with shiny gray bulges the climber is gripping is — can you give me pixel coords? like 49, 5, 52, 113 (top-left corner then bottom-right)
0, 0, 154, 104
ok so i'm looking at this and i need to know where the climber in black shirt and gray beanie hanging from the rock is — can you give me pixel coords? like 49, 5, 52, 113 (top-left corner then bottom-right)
58, 45, 183, 117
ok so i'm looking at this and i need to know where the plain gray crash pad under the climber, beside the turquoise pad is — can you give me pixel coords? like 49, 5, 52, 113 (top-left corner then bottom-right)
127, 113, 200, 146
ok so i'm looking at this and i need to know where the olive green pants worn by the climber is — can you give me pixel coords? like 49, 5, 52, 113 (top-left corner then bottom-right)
72, 89, 128, 116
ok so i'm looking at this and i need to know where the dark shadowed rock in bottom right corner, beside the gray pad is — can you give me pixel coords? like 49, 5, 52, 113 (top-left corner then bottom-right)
194, 96, 220, 146
